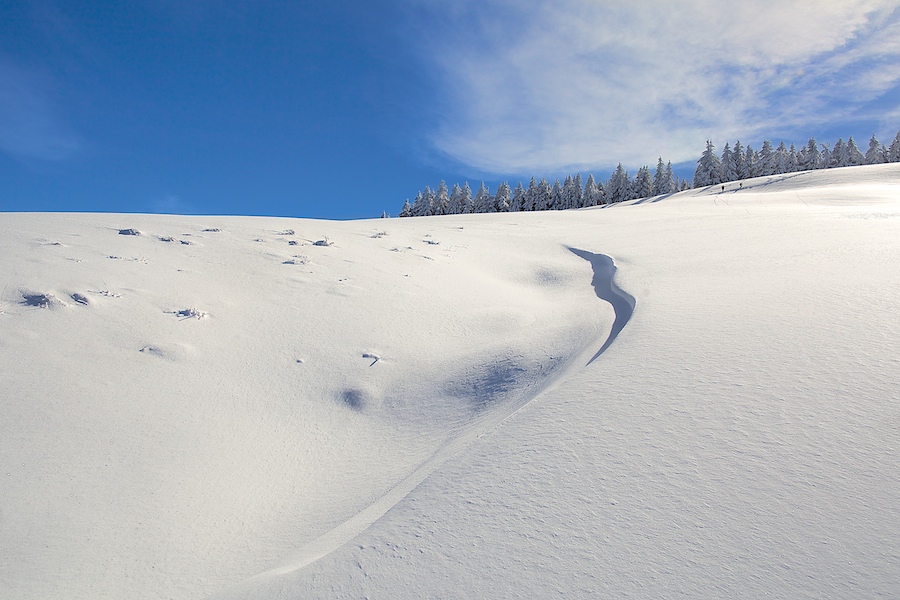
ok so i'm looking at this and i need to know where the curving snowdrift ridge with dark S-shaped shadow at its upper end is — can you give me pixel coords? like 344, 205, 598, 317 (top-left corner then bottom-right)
208, 246, 635, 600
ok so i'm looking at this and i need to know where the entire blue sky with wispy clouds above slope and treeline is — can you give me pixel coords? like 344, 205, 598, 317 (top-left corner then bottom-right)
0, 0, 900, 218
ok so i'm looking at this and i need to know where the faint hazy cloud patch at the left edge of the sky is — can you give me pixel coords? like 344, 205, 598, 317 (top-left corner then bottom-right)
0, 60, 80, 160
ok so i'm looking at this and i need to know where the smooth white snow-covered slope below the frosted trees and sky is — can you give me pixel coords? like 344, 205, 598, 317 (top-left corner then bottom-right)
0, 165, 900, 598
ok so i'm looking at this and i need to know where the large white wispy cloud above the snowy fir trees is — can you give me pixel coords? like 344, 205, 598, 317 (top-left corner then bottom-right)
411, 0, 900, 173
